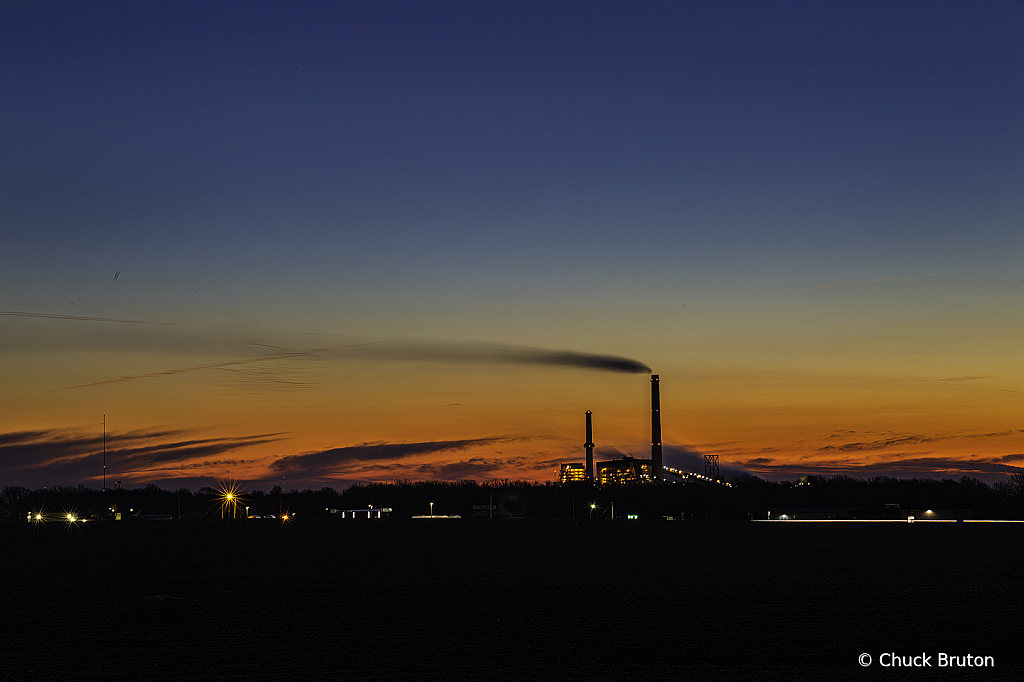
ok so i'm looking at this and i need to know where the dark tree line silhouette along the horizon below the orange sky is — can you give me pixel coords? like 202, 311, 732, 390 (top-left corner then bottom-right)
0, 473, 1024, 520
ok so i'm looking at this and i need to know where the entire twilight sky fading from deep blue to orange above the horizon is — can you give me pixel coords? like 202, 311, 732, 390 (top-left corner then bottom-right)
0, 0, 1024, 487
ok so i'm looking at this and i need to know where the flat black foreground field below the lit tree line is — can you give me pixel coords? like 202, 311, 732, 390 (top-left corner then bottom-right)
0, 519, 1024, 682
